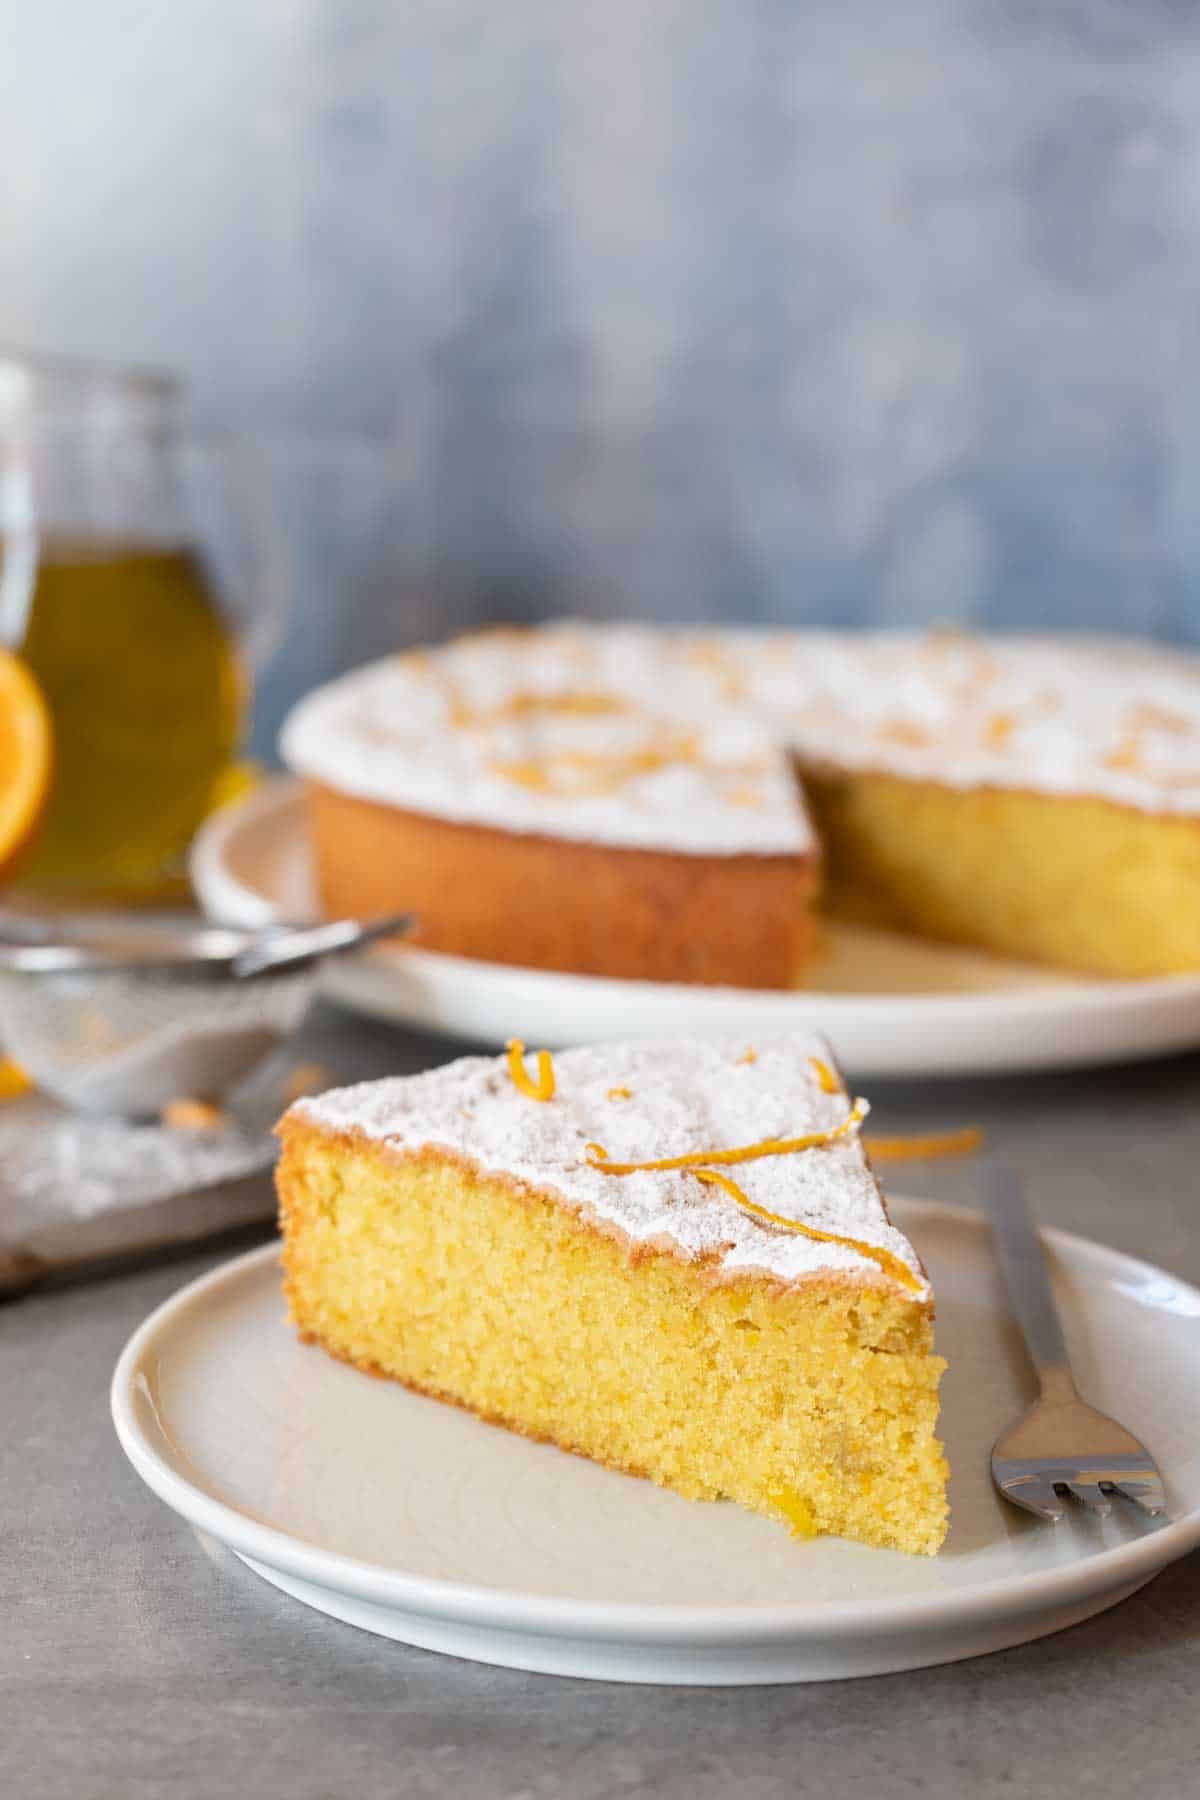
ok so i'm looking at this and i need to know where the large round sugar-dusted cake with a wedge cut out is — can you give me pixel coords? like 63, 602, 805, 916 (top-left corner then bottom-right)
281, 623, 1200, 988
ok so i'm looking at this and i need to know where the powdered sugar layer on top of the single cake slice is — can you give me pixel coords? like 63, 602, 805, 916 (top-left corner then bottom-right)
293, 1035, 919, 1280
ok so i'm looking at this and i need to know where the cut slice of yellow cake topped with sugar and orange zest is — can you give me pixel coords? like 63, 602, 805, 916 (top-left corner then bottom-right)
277, 1035, 946, 1553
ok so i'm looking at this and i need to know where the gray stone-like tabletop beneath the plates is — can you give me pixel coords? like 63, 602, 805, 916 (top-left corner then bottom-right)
0, 1012, 1200, 1800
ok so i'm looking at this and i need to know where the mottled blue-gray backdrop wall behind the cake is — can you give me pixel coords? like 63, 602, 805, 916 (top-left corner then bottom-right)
0, 0, 1200, 742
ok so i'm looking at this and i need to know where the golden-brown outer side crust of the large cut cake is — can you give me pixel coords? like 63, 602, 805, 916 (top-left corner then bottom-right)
306, 781, 817, 988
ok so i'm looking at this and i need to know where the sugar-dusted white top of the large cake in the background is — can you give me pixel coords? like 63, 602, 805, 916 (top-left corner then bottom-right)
282, 623, 1200, 855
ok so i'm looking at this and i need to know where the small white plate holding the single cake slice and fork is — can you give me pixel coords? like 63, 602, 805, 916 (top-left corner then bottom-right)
112, 1201, 1200, 1683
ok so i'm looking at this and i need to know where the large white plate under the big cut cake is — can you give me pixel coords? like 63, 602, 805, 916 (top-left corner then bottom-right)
191, 781, 1200, 1078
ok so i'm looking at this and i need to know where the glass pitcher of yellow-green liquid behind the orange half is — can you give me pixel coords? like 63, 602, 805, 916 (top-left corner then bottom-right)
0, 349, 282, 904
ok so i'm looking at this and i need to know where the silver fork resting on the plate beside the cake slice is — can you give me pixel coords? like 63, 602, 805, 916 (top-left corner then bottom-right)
981, 1166, 1166, 1521
